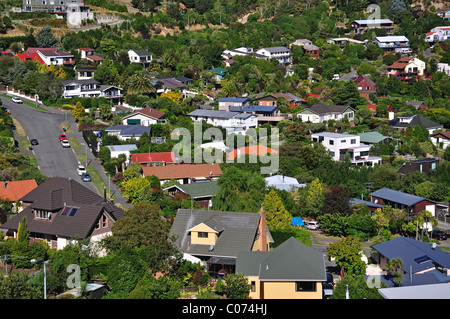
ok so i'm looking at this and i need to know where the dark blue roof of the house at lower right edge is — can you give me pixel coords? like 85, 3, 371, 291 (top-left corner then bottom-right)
372, 237, 450, 280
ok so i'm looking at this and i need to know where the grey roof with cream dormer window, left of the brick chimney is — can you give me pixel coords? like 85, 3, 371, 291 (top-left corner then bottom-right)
170, 209, 270, 258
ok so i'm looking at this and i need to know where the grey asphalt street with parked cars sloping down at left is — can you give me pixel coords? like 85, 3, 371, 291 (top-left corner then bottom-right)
0, 97, 129, 207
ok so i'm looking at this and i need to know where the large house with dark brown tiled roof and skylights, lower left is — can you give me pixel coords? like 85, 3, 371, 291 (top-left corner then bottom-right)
0, 177, 124, 253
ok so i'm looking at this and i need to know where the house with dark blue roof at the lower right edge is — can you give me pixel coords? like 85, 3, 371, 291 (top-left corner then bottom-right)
372, 237, 450, 288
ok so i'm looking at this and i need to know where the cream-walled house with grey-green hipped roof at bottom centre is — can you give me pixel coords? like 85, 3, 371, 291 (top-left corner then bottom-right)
236, 237, 327, 299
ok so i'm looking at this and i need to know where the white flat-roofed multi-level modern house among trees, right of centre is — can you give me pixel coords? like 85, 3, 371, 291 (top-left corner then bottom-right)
311, 132, 381, 166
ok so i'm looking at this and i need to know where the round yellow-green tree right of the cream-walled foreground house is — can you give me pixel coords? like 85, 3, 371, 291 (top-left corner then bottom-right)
327, 236, 366, 275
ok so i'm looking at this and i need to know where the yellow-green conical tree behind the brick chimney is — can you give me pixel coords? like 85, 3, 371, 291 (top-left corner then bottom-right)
263, 188, 292, 229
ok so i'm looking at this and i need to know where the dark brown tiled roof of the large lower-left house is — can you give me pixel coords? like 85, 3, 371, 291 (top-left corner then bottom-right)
0, 177, 124, 239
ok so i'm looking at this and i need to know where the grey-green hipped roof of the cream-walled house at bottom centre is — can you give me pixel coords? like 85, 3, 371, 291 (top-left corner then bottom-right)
236, 237, 326, 281
